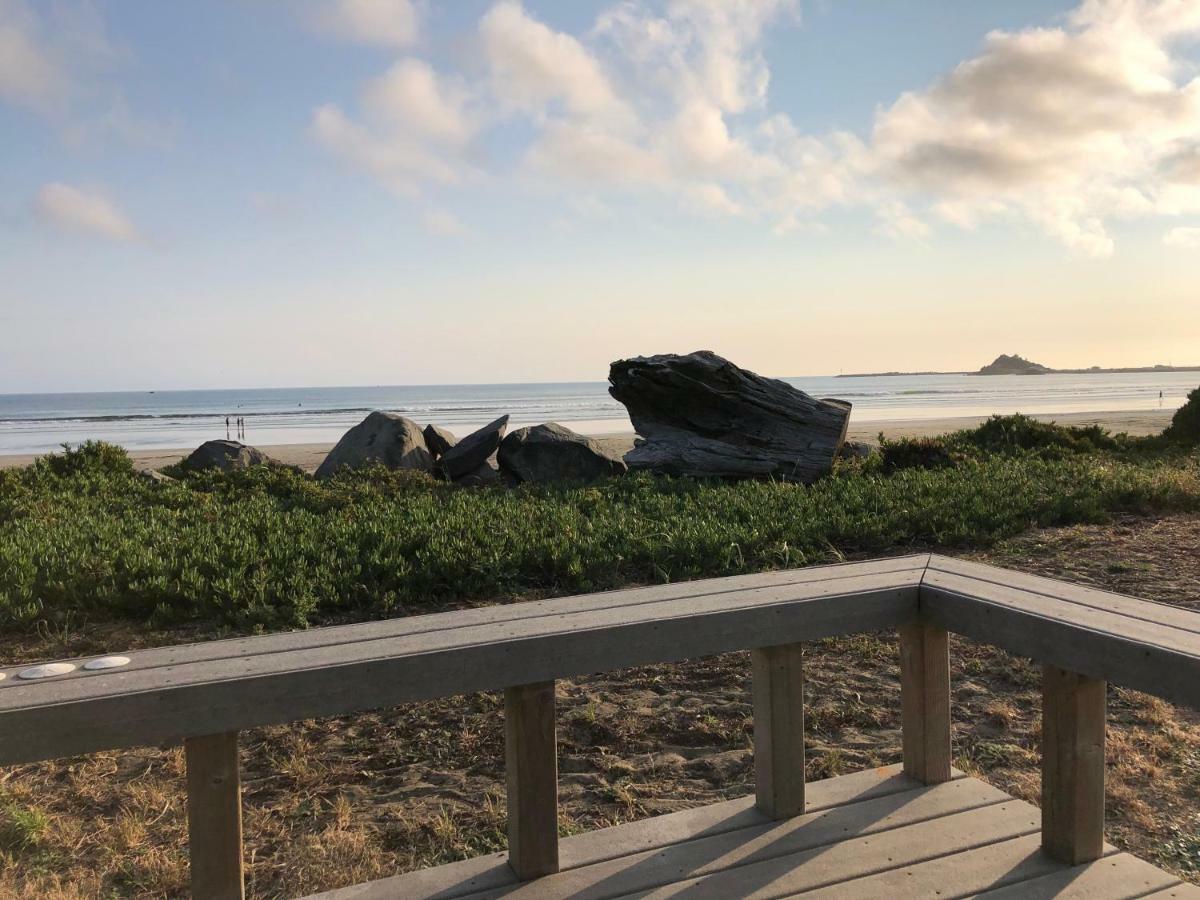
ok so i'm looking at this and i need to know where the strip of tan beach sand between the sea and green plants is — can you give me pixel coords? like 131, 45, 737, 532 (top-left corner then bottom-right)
0, 409, 1174, 472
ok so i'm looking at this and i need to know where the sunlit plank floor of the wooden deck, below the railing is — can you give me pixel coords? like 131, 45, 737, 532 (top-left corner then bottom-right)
311, 767, 1200, 900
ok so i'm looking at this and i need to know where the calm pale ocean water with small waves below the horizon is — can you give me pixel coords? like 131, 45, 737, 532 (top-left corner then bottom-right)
0, 372, 1200, 454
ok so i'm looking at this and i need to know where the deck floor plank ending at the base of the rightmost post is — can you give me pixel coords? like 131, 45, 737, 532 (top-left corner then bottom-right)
773, 835, 1099, 900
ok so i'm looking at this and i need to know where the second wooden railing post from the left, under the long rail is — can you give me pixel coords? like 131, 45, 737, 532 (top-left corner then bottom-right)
504, 682, 558, 881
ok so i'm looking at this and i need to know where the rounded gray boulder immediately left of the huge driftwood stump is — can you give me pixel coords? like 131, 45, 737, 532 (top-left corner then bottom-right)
498, 422, 625, 481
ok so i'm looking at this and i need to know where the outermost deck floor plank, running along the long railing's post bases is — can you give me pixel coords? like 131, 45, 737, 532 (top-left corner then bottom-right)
304, 766, 960, 900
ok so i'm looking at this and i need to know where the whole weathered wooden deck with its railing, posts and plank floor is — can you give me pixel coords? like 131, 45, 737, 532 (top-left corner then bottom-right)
0, 554, 1200, 900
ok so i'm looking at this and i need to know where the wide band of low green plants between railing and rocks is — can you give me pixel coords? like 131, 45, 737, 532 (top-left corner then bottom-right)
0, 419, 1200, 629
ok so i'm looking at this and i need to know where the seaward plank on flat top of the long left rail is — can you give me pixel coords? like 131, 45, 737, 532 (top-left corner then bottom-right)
0, 553, 929, 690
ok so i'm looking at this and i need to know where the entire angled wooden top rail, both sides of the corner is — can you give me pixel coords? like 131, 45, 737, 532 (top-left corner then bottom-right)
0, 554, 1200, 764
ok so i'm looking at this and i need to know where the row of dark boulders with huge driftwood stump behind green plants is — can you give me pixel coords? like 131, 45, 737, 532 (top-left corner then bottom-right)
177, 350, 871, 485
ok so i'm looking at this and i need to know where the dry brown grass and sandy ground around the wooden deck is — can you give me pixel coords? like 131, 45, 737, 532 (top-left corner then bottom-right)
0, 516, 1200, 898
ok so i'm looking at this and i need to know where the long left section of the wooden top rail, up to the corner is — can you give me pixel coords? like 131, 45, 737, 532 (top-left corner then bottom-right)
0, 554, 929, 764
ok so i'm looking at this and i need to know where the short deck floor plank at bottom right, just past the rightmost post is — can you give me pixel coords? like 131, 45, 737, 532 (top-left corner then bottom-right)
974, 853, 1200, 900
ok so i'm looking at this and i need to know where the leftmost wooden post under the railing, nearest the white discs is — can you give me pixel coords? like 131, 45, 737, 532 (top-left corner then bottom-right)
184, 731, 246, 900
